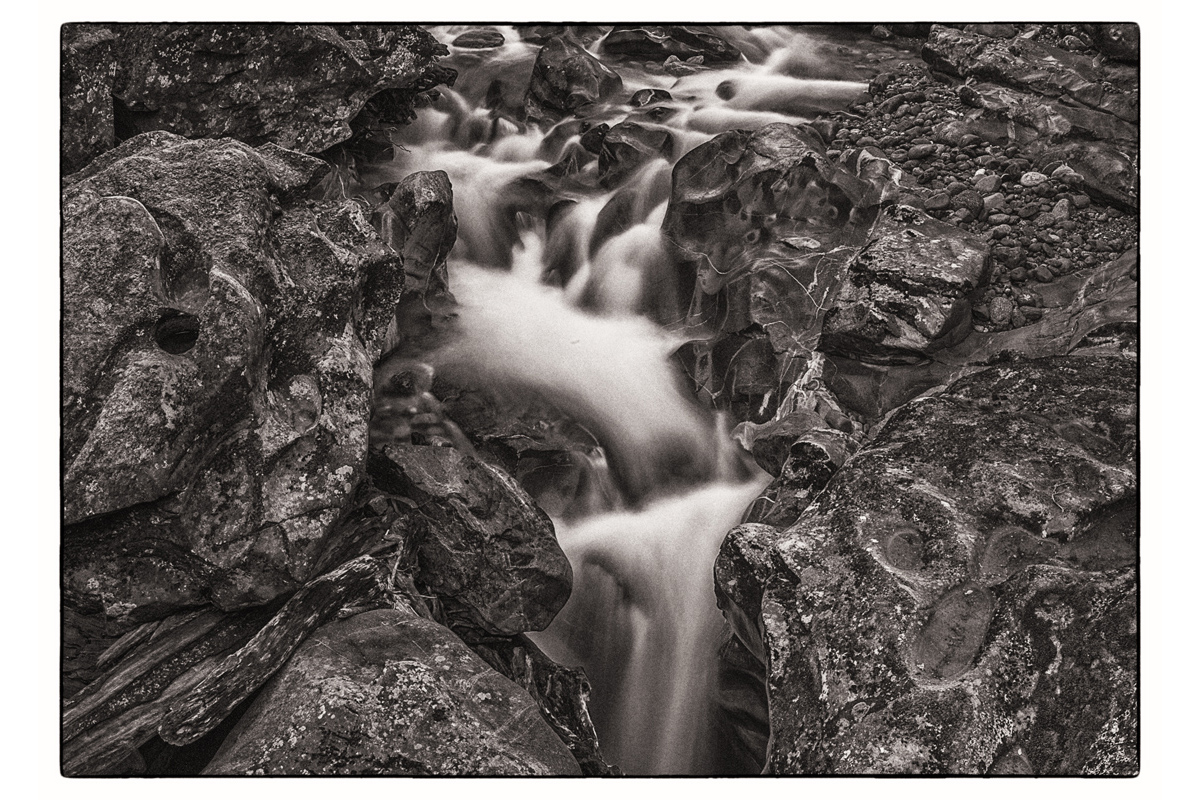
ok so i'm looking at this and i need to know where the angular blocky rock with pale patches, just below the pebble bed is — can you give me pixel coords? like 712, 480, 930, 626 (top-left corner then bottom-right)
821, 206, 991, 363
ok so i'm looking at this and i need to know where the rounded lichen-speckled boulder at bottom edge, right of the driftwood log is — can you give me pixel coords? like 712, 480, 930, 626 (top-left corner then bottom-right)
204, 609, 580, 775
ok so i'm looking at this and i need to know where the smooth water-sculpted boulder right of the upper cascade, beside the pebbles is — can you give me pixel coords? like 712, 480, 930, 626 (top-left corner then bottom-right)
662, 124, 899, 422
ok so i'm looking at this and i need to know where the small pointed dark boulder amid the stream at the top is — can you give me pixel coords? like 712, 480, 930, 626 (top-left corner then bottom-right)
526, 38, 624, 122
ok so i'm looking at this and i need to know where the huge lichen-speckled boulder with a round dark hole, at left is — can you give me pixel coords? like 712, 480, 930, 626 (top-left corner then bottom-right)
62, 133, 403, 619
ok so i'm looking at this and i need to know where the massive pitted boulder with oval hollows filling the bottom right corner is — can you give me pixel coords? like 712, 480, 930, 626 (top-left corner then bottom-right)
734, 350, 1138, 775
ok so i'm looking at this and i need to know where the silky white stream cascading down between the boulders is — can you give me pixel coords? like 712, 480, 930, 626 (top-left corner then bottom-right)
362, 26, 921, 775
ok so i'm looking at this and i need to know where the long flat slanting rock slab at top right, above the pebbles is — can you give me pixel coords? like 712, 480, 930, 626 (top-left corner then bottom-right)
920, 25, 1138, 122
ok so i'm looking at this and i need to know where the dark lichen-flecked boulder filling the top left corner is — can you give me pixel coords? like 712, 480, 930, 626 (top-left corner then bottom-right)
62, 24, 446, 172
